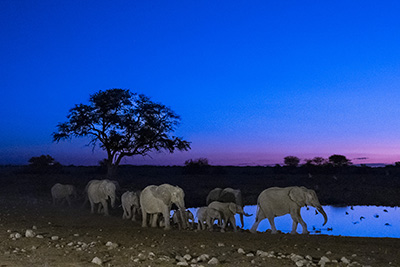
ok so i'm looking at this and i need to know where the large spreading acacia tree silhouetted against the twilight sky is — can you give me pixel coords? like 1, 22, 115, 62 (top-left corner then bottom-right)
53, 89, 190, 177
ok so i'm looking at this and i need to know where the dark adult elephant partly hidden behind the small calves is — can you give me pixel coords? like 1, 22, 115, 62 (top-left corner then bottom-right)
206, 187, 244, 228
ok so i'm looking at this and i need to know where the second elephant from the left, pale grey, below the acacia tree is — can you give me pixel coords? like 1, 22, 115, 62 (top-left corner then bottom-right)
86, 179, 116, 216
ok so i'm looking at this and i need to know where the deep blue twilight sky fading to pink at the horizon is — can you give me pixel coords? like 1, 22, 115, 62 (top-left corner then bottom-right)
0, 0, 400, 168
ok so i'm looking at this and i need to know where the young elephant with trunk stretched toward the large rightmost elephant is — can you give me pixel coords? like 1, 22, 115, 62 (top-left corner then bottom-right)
207, 201, 251, 232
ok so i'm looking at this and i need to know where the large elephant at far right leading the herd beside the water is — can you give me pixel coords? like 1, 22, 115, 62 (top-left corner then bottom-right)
250, 186, 328, 234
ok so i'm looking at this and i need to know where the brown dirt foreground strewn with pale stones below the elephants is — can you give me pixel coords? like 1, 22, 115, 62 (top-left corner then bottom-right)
0, 196, 400, 266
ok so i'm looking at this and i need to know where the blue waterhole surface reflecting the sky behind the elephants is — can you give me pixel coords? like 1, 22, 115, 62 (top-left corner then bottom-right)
190, 206, 400, 238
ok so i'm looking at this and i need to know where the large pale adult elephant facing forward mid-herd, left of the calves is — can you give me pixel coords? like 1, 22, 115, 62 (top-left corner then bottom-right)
140, 184, 186, 230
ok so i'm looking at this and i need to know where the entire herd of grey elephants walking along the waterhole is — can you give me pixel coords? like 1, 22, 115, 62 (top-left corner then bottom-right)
51, 179, 328, 234
